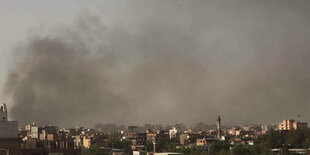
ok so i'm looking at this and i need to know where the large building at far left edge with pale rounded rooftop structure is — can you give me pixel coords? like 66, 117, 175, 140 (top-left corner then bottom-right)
0, 104, 20, 155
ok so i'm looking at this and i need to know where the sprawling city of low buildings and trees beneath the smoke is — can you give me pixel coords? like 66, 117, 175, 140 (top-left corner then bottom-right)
0, 101, 310, 155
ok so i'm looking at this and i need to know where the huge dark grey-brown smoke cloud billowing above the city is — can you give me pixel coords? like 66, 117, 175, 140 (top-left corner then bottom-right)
4, 0, 310, 126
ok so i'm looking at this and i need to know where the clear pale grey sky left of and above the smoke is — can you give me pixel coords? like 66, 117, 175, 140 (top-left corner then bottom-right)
0, 0, 125, 95
